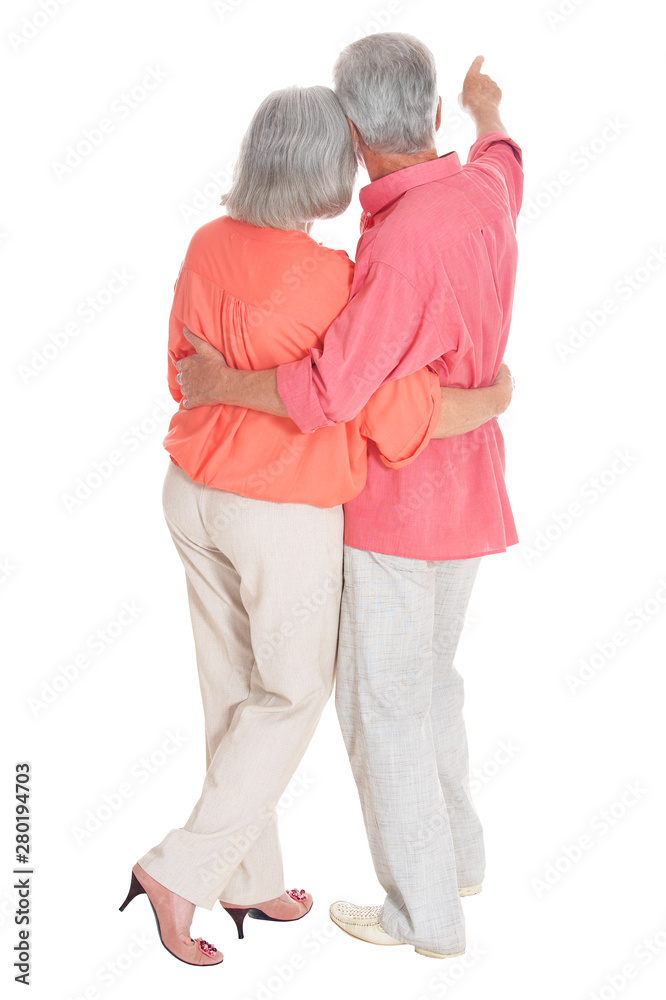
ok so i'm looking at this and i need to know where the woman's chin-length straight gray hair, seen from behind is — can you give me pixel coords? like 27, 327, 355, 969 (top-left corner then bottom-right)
221, 87, 357, 229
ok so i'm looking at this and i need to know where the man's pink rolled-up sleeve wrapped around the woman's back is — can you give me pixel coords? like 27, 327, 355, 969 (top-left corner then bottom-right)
277, 262, 457, 432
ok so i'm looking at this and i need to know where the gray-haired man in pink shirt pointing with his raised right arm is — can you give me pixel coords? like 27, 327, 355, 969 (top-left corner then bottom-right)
176, 33, 522, 957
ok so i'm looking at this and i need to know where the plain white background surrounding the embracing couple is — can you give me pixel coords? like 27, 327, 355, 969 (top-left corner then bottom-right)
0, 0, 666, 1000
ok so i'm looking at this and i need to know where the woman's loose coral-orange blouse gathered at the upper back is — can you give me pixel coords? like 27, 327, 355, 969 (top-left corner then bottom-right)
164, 216, 441, 507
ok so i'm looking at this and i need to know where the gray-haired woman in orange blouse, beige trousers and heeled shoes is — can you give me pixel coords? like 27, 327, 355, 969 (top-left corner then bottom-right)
121, 87, 507, 965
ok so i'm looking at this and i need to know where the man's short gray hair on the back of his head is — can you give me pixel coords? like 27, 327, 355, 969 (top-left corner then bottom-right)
333, 31, 438, 153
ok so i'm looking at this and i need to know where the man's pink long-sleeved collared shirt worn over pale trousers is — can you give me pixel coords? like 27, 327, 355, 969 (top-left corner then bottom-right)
277, 132, 523, 560
